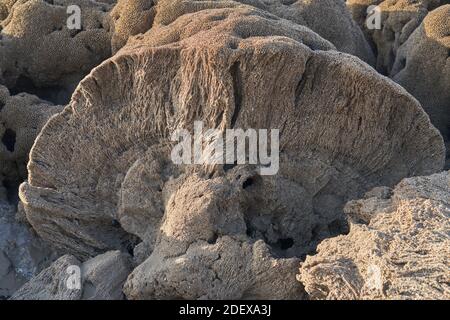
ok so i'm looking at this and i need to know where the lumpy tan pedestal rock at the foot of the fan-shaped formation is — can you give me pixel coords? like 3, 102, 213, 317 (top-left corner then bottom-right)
124, 171, 303, 299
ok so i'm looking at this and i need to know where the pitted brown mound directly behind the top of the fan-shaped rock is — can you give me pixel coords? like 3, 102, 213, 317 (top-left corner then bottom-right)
111, 0, 375, 64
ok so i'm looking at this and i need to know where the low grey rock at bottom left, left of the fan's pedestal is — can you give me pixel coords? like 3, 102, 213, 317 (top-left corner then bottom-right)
11, 251, 131, 300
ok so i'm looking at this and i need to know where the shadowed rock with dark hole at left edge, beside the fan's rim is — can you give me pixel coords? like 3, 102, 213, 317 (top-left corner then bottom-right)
0, 85, 62, 203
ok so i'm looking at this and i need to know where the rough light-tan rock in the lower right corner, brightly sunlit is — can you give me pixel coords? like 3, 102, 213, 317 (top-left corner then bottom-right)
298, 171, 450, 300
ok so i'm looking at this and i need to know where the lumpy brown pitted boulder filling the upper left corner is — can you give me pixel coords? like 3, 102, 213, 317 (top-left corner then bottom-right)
0, 0, 111, 103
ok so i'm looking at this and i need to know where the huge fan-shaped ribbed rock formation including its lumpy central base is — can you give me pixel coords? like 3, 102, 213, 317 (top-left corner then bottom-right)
20, 7, 445, 299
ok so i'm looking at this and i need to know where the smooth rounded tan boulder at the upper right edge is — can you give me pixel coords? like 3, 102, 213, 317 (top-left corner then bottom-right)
392, 4, 450, 167
